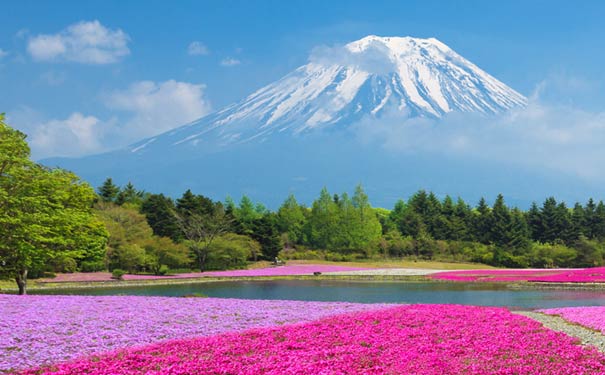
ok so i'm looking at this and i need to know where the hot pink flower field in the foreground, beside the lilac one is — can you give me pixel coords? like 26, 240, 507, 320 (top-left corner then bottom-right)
16, 305, 605, 375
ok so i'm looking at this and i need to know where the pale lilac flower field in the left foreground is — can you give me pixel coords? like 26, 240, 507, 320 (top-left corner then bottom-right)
0, 294, 392, 373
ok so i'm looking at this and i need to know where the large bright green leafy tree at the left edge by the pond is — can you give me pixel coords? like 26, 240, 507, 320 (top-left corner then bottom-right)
0, 115, 107, 294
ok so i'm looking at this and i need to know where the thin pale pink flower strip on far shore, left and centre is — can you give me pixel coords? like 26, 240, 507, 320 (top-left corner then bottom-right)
43, 264, 368, 282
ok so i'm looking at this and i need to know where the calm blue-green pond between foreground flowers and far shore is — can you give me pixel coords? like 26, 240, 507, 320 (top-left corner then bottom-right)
32, 280, 605, 309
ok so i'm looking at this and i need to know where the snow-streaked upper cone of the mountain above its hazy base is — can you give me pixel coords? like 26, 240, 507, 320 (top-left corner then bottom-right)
130, 36, 526, 153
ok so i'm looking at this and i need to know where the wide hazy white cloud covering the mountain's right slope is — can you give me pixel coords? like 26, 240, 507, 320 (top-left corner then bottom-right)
354, 85, 605, 181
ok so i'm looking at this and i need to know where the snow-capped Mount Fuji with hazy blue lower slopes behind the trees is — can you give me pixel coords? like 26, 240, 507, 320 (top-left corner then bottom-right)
43, 36, 588, 207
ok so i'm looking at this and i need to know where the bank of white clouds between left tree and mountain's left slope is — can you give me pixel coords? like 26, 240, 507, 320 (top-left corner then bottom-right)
8, 80, 211, 160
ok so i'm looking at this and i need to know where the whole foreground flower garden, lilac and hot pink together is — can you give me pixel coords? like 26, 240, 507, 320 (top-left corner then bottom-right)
0, 295, 605, 375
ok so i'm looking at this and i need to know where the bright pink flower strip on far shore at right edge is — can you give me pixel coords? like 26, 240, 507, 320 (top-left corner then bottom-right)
430, 267, 605, 283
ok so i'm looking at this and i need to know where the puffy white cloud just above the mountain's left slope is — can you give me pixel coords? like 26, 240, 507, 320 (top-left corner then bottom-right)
105, 80, 211, 141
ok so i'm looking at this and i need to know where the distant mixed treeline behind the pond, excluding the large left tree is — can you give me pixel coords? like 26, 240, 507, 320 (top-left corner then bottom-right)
98, 179, 605, 270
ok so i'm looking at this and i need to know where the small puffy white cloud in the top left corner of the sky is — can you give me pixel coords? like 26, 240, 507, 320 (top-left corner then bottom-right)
27, 20, 130, 64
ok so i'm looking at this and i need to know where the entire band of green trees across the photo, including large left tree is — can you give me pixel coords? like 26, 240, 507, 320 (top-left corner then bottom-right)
0, 115, 605, 291
